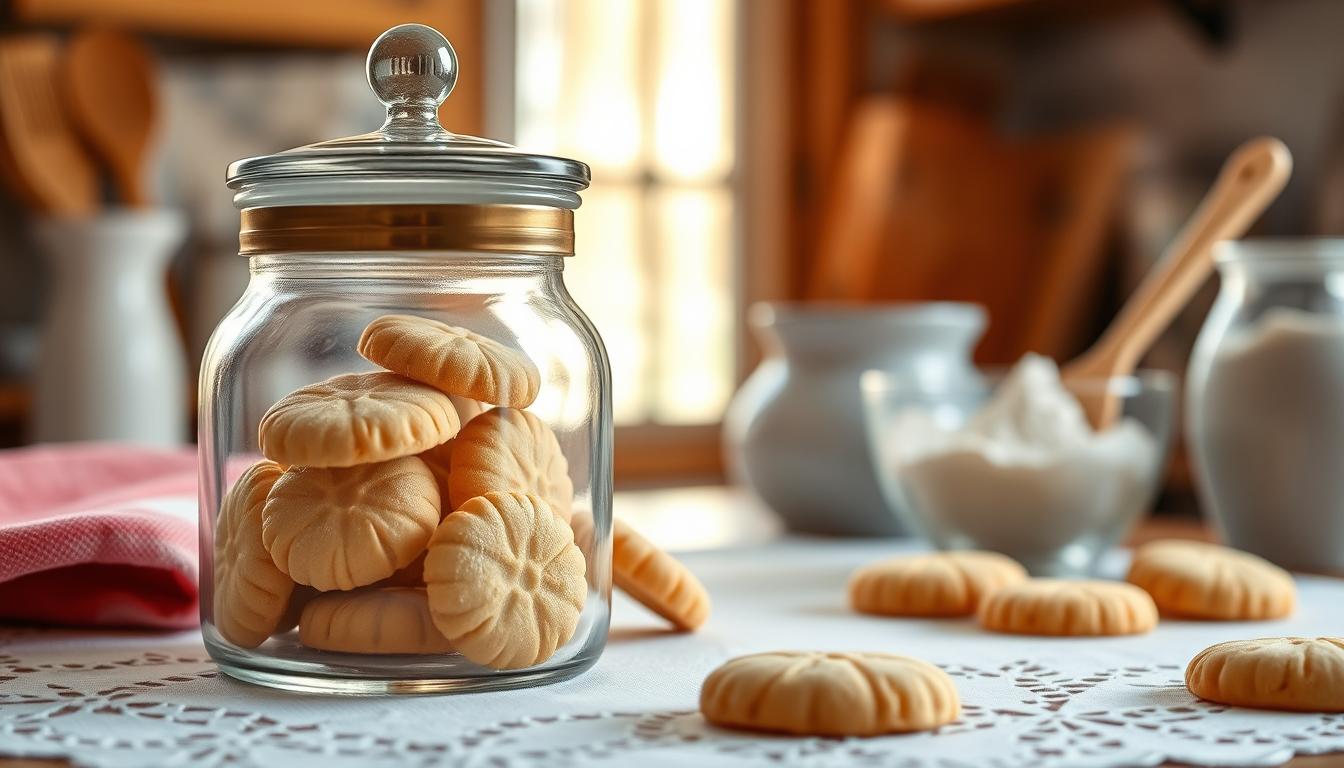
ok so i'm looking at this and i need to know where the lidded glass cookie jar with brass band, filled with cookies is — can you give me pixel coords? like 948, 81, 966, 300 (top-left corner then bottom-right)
199, 24, 612, 693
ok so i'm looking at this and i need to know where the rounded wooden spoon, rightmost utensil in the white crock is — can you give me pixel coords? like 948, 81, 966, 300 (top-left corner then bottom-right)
62, 30, 159, 207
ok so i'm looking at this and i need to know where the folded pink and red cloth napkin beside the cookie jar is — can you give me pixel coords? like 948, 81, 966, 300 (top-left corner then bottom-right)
0, 444, 199, 628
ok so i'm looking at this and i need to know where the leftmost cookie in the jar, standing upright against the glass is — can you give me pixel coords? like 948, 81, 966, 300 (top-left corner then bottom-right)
214, 461, 294, 648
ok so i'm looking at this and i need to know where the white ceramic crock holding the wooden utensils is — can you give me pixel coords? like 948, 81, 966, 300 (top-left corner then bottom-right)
32, 210, 190, 445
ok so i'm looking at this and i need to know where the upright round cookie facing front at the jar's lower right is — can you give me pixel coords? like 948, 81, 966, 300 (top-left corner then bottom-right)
425, 494, 587, 670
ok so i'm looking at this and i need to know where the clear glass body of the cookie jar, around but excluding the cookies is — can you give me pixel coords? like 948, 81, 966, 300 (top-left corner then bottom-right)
199, 250, 612, 693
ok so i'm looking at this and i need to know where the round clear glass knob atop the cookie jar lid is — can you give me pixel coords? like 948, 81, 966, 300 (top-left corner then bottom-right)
367, 24, 457, 141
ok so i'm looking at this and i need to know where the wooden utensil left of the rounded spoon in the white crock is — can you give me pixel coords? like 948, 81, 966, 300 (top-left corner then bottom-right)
0, 36, 98, 215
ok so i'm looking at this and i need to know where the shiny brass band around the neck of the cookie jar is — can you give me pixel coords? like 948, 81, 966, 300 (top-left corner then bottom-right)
238, 204, 574, 256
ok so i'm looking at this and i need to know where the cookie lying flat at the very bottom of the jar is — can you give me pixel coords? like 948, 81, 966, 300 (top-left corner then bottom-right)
298, 586, 453, 654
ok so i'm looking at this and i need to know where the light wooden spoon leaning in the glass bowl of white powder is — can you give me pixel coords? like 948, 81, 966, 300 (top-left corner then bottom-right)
1062, 137, 1293, 430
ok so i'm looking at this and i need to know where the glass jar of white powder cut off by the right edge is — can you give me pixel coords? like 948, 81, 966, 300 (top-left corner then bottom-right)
1185, 239, 1344, 570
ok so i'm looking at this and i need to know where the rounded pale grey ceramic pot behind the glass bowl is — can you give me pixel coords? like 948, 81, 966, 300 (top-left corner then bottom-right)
724, 303, 985, 535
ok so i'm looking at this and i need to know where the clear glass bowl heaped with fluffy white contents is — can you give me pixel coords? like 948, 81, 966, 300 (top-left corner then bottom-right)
863, 355, 1175, 576
